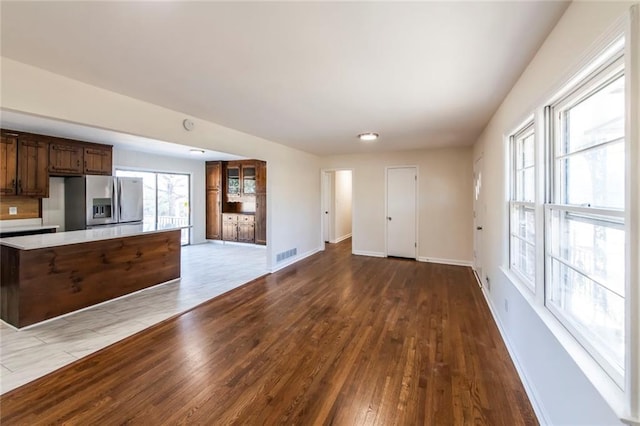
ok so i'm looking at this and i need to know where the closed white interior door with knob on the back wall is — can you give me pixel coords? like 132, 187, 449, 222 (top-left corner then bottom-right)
386, 167, 418, 259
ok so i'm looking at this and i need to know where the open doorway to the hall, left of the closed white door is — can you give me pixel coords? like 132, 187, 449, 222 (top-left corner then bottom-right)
322, 170, 353, 244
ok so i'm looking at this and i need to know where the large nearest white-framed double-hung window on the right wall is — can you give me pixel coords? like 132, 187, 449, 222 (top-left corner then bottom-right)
545, 54, 625, 385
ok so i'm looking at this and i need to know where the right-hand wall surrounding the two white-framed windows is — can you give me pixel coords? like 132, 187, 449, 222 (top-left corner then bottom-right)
474, 2, 630, 425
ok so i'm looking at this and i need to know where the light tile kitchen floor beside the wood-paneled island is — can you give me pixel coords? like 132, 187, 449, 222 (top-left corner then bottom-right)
0, 243, 267, 394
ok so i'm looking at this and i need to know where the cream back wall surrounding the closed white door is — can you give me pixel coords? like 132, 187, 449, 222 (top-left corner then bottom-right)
322, 148, 473, 265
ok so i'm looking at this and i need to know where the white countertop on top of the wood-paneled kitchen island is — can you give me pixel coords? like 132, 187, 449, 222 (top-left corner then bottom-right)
0, 224, 190, 250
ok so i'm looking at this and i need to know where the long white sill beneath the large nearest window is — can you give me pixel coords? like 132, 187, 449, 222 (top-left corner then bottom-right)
500, 267, 640, 426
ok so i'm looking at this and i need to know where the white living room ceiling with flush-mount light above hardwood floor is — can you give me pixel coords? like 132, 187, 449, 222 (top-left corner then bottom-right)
1, 1, 568, 155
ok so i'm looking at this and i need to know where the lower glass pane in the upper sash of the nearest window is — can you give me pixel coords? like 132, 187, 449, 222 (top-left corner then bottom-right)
559, 141, 625, 209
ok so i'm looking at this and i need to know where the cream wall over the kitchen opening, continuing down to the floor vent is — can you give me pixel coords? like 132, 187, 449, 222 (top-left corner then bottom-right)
0, 57, 321, 267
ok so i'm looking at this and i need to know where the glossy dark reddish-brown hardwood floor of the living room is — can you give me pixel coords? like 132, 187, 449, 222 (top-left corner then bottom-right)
0, 240, 537, 425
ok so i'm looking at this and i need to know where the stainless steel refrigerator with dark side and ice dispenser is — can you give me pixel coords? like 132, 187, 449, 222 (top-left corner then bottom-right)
64, 176, 143, 231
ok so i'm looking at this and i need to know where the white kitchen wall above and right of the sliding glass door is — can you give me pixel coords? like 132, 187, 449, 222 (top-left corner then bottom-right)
113, 148, 206, 244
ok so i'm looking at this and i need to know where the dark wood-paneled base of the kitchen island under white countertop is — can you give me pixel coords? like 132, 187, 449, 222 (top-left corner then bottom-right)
0, 225, 181, 328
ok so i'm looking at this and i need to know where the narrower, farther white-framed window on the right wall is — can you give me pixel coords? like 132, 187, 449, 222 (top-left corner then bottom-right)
509, 121, 536, 290
